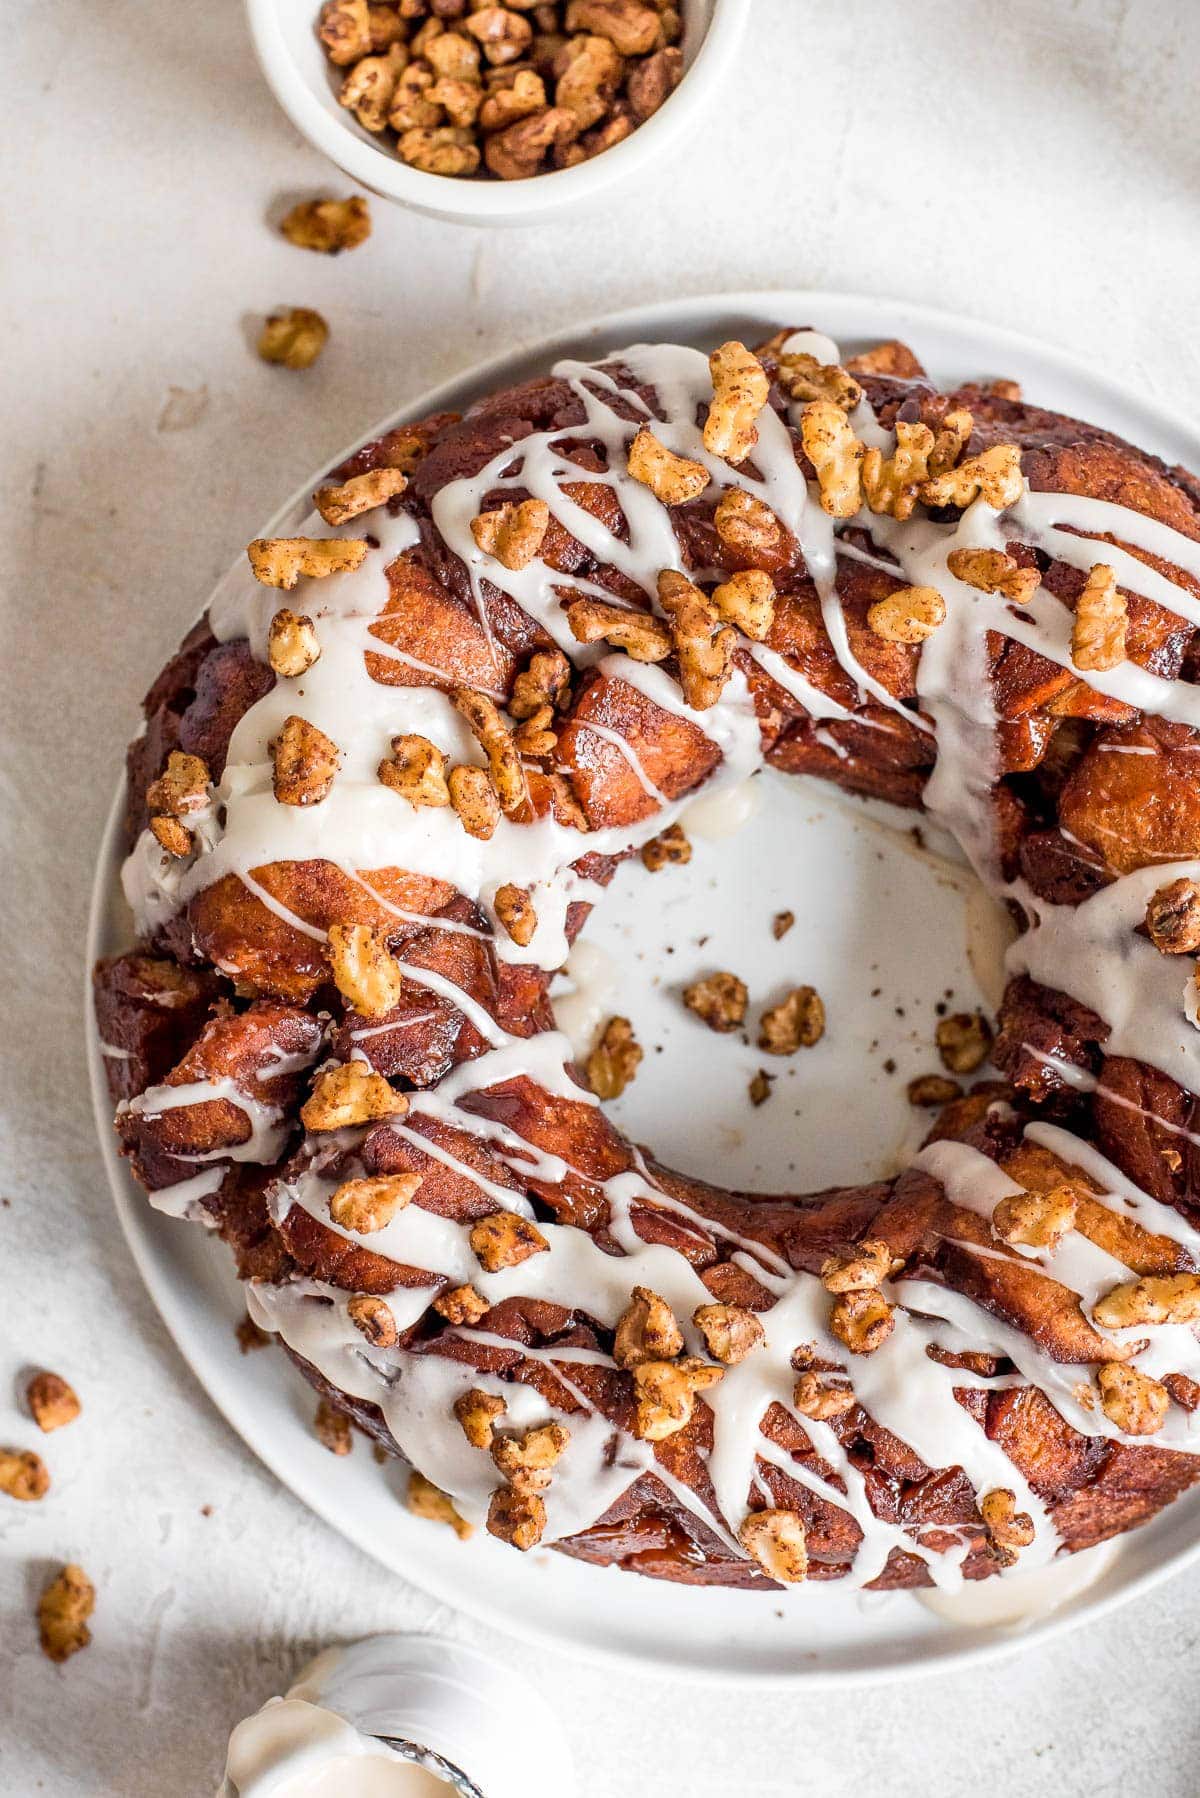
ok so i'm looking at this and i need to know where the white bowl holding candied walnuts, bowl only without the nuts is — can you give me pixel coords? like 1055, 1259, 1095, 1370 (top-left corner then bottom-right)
246, 0, 750, 225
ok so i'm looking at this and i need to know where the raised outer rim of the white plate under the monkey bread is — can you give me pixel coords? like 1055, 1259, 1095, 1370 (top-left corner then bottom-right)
83, 288, 1200, 1690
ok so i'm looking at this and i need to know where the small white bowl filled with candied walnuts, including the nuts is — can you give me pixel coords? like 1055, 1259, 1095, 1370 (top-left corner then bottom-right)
246, 0, 748, 225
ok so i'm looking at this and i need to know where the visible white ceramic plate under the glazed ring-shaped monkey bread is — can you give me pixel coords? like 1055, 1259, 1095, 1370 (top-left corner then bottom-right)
88, 291, 1200, 1685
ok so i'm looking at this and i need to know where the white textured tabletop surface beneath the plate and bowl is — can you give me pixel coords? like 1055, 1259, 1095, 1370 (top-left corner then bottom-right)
0, 0, 1200, 1798
